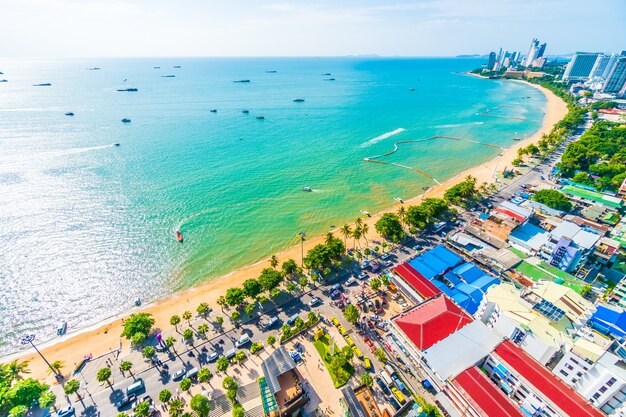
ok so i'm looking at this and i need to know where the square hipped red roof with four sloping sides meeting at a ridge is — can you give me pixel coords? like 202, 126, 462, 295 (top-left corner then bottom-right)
394, 295, 473, 351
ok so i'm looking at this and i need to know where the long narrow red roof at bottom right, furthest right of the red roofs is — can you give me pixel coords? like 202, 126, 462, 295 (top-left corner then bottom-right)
494, 340, 604, 417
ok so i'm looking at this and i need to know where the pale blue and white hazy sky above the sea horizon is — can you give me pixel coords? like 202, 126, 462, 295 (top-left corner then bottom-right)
0, 0, 626, 58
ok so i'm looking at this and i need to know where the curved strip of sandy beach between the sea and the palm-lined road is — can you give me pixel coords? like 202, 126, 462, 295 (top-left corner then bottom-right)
6, 78, 567, 380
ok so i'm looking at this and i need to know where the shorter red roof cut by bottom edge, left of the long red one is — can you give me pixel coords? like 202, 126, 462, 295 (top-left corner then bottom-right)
452, 366, 523, 417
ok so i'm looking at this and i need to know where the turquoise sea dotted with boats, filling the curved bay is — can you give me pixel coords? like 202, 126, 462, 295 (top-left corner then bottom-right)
0, 58, 545, 353
